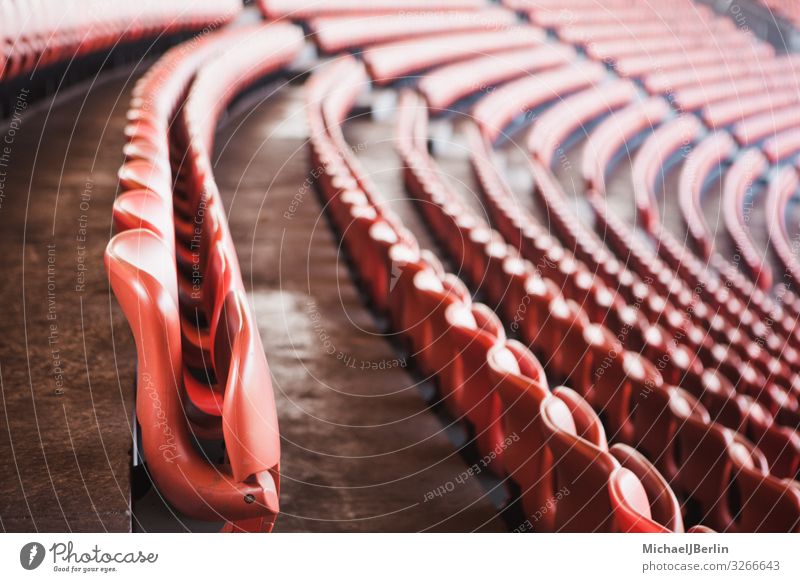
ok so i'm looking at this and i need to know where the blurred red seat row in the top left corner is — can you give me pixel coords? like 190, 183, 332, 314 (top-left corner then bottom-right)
0, 0, 241, 82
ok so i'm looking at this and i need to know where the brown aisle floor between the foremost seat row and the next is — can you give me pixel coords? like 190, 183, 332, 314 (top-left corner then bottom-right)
209, 86, 505, 532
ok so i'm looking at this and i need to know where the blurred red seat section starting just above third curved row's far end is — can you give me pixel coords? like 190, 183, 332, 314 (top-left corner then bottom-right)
418, 44, 575, 112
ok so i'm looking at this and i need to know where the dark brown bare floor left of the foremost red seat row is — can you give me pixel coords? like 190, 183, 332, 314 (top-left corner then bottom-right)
0, 70, 135, 531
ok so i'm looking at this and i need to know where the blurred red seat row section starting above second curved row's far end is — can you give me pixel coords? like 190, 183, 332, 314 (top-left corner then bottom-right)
363, 26, 546, 85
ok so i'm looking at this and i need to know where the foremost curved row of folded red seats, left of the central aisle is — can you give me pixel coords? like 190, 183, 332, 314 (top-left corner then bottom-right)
106, 25, 303, 531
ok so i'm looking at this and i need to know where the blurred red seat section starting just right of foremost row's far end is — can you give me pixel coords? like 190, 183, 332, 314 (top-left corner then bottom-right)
308, 8, 516, 55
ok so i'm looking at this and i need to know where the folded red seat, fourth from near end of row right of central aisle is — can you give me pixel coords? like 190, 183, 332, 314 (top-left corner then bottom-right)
439, 303, 506, 475
